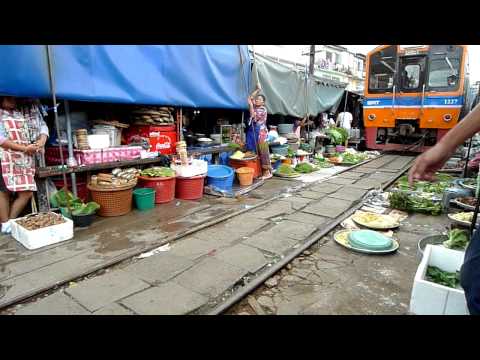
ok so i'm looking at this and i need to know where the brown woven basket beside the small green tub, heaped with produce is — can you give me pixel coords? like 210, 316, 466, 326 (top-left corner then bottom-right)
87, 182, 136, 217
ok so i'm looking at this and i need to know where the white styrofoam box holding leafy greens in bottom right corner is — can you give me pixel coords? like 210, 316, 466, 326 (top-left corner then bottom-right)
410, 244, 469, 315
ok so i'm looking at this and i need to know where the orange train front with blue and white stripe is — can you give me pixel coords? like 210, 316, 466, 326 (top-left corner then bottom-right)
363, 45, 468, 152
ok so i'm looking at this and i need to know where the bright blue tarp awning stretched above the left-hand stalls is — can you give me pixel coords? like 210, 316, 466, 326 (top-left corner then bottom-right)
0, 45, 250, 109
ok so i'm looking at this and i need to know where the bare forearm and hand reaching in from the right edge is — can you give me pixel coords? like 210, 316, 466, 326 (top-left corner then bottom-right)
408, 105, 480, 184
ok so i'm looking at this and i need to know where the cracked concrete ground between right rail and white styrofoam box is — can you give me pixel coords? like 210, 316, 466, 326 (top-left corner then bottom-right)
228, 214, 450, 315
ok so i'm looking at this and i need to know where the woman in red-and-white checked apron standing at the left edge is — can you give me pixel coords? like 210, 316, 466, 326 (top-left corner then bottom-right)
0, 97, 48, 233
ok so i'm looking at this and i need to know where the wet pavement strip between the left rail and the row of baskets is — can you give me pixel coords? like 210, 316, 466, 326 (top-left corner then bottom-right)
0, 162, 352, 308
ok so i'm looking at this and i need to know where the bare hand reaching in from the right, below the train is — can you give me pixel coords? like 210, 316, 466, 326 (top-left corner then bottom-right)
408, 143, 453, 185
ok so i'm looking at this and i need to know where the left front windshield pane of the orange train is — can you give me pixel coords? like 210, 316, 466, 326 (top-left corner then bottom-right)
368, 45, 397, 93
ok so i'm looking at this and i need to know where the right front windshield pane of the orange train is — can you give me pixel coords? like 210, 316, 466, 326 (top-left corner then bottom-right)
428, 45, 462, 91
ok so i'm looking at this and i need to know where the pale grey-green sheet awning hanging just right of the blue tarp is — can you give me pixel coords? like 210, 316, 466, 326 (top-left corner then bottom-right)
251, 54, 344, 117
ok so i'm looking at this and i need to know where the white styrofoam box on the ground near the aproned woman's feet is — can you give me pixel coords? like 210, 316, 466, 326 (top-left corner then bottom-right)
12, 217, 73, 250
